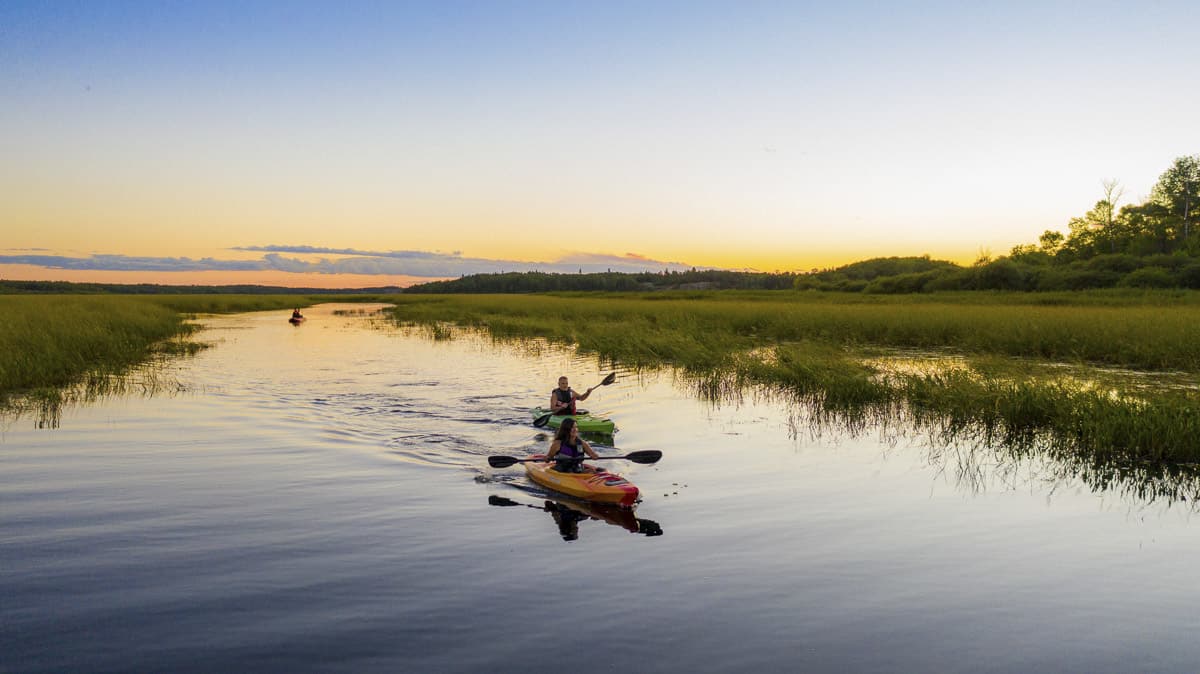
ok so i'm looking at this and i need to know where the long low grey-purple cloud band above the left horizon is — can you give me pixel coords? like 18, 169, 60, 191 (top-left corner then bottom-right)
0, 246, 691, 278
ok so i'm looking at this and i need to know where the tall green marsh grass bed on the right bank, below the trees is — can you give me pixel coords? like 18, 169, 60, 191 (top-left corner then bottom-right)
392, 293, 1200, 464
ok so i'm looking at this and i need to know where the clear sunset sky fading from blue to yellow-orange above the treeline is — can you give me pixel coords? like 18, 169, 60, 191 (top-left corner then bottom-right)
0, 0, 1200, 288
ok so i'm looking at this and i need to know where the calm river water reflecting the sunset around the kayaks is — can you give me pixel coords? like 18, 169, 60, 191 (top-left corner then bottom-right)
0, 306, 1200, 673
